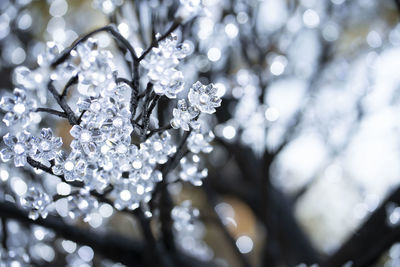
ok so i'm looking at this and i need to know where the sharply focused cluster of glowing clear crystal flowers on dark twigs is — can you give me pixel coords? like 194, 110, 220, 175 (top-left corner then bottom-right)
0, 6, 221, 241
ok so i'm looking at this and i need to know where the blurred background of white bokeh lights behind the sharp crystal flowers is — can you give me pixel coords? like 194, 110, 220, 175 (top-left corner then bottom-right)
0, 0, 400, 266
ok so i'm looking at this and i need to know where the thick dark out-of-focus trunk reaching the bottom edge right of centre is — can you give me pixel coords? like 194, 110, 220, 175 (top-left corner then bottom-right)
207, 147, 319, 266
